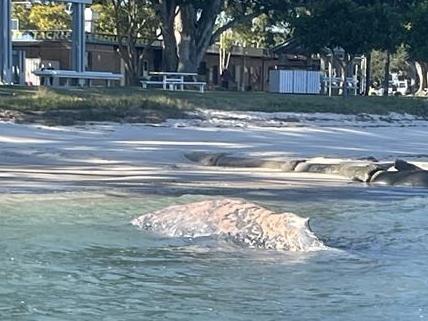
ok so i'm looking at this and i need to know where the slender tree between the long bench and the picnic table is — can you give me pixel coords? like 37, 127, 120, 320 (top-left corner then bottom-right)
92, 0, 159, 85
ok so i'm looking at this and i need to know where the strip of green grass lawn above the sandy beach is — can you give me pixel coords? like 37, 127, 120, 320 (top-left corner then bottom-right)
0, 87, 428, 125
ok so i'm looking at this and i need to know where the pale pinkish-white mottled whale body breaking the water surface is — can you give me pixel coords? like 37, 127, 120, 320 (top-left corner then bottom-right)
132, 199, 325, 251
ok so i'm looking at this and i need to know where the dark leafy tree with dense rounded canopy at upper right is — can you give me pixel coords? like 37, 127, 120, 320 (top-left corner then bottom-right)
296, 0, 414, 95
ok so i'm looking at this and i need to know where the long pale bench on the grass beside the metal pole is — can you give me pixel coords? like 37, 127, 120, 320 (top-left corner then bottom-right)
33, 69, 123, 87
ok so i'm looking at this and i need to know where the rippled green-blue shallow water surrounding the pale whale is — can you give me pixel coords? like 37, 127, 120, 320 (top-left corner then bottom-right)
0, 194, 428, 321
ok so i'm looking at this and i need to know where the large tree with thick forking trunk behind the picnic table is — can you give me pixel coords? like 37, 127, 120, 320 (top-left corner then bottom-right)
156, 0, 290, 72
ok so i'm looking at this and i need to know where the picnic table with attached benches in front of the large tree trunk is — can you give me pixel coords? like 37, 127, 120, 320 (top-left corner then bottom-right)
141, 71, 207, 93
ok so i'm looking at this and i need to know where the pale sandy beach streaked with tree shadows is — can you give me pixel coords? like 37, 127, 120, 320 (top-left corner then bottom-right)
0, 113, 428, 195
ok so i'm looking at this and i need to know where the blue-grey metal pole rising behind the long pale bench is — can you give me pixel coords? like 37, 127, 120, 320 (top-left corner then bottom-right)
71, 3, 86, 72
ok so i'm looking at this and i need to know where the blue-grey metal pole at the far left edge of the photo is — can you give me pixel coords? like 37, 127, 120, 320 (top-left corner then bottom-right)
0, 0, 12, 84
